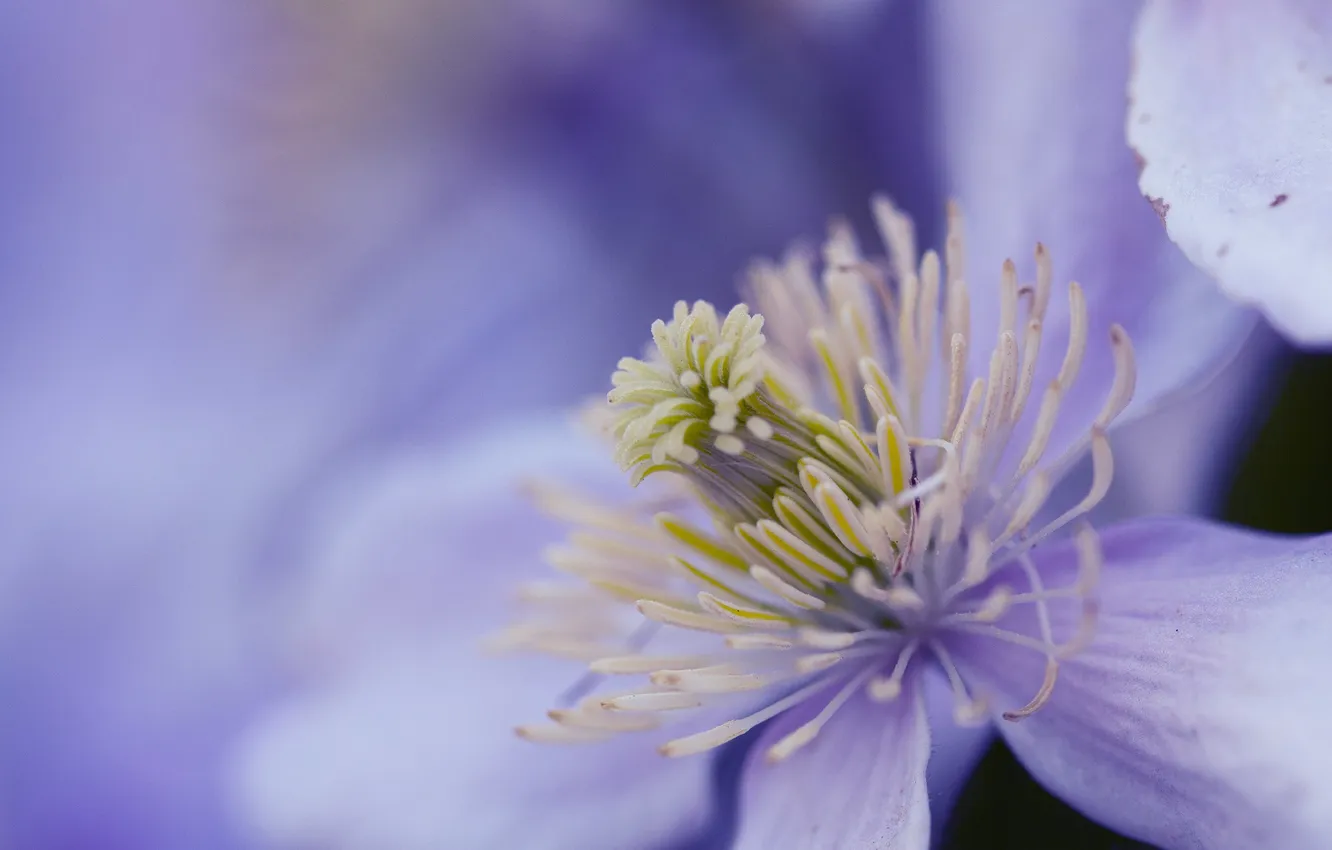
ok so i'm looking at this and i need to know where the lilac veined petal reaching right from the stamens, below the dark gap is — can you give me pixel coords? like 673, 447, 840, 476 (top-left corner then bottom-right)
952, 520, 1332, 849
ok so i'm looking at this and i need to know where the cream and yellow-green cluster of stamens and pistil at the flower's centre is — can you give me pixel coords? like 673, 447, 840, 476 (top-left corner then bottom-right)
497, 199, 1135, 762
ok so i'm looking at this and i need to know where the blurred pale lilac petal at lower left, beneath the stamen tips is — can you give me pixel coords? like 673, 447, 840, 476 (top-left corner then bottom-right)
236, 643, 711, 850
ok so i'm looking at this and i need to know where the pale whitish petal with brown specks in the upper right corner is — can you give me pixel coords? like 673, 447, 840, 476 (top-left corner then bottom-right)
1128, 0, 1332, 345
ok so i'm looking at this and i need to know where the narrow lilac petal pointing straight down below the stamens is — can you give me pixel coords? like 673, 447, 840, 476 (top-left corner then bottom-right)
735, 679, 930, 850
